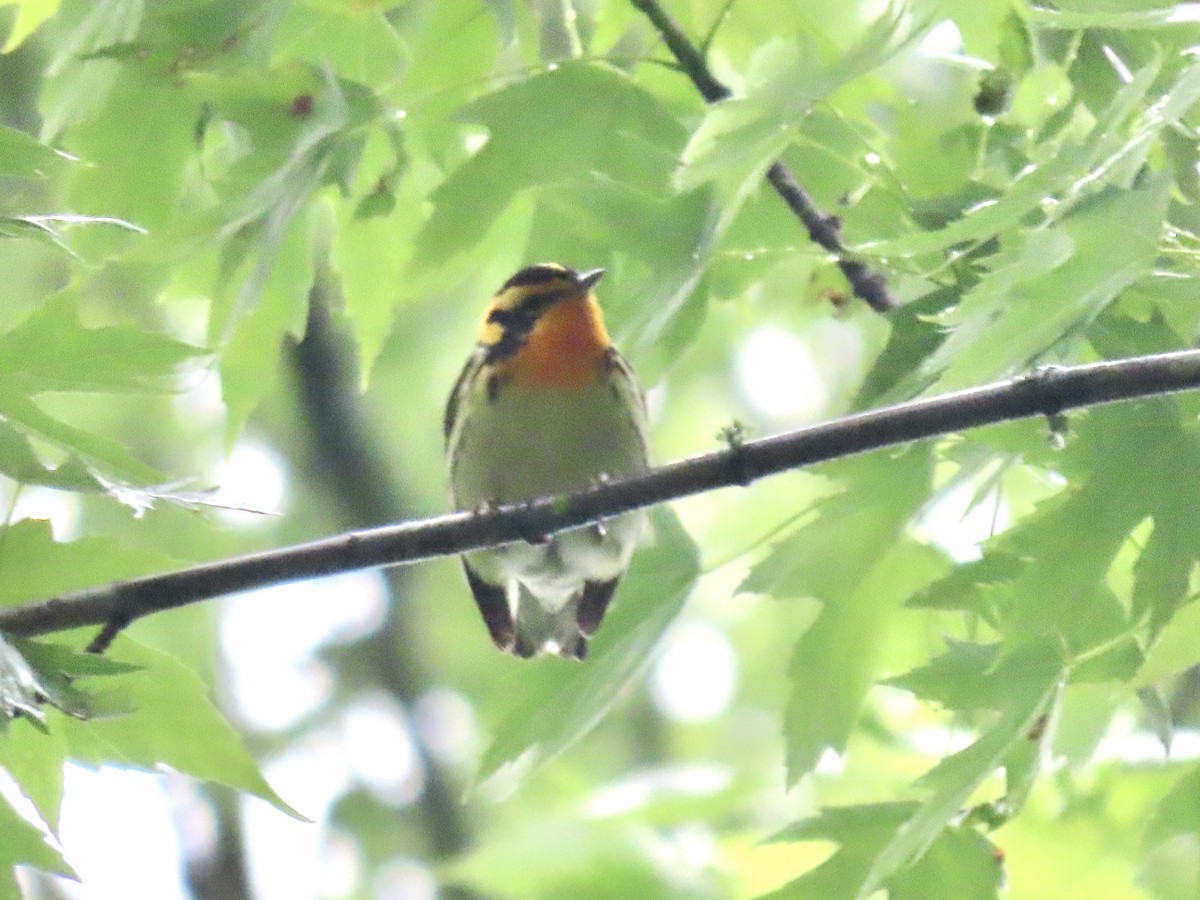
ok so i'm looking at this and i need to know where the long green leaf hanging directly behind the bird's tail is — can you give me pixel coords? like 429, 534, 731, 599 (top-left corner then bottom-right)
479, 506, 700, 786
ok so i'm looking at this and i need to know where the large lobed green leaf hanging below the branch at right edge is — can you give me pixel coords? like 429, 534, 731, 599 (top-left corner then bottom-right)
908, 400, 1200, 672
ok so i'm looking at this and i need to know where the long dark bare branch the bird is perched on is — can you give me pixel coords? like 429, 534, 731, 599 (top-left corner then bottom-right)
0, 350, 1200, 635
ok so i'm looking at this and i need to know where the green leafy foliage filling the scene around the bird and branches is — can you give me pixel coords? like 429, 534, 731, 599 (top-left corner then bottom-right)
0, 0, 1200, 900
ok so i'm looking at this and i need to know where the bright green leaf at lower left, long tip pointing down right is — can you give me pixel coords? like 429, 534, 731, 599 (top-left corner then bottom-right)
50, 637, 304, 820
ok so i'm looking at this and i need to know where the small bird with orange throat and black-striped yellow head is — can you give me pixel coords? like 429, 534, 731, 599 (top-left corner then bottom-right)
443, 263, 650, 660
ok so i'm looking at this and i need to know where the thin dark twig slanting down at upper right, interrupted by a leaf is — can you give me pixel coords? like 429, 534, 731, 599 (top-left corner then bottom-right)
630, 0, 898, 312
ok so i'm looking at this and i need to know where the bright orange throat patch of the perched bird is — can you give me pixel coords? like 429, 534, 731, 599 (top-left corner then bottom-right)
503, 296, 612, 391
